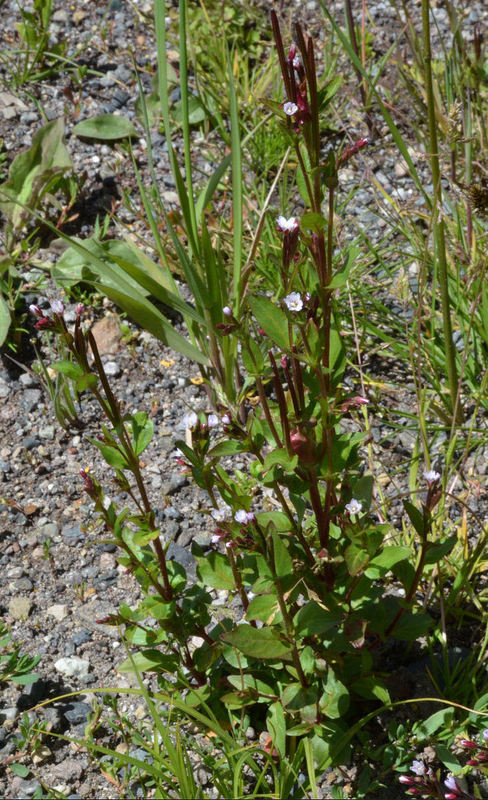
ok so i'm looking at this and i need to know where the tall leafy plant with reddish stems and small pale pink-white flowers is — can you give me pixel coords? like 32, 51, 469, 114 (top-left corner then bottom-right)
28, 13, 464, 792
